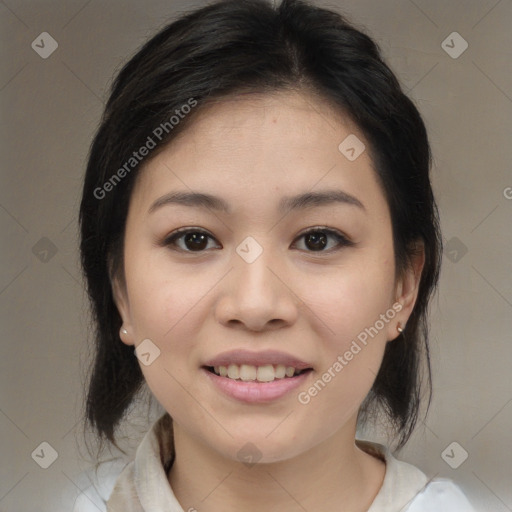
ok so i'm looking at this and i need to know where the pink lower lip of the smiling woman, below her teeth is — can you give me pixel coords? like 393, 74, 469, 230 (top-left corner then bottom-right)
201, 368, 312, 404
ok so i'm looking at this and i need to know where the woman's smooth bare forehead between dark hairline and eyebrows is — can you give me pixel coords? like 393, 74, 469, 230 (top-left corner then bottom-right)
129, 92, 385, 220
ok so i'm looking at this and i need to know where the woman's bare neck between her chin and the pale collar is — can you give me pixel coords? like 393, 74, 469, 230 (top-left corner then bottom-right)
169, 423, 385, 512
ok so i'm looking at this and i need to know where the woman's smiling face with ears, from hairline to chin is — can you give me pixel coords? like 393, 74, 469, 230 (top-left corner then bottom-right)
114, 93, 422, 462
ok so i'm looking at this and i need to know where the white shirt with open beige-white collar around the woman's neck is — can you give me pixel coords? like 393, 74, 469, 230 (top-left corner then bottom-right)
73, 413, 475, 512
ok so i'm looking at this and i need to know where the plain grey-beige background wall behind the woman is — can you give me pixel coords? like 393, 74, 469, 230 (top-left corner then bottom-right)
0, 0, 512, 512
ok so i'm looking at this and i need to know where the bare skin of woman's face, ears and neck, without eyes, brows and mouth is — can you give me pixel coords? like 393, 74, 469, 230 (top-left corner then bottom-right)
113, 92, 424, 512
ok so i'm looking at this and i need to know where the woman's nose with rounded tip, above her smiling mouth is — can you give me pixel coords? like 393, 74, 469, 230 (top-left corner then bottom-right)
215, 242, 300, 331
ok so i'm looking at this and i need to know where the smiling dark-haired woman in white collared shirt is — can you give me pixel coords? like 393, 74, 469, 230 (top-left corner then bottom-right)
75, 0, 473, 512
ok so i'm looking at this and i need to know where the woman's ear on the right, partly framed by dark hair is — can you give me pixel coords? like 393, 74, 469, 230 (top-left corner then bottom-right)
388, 240, 425, 341
